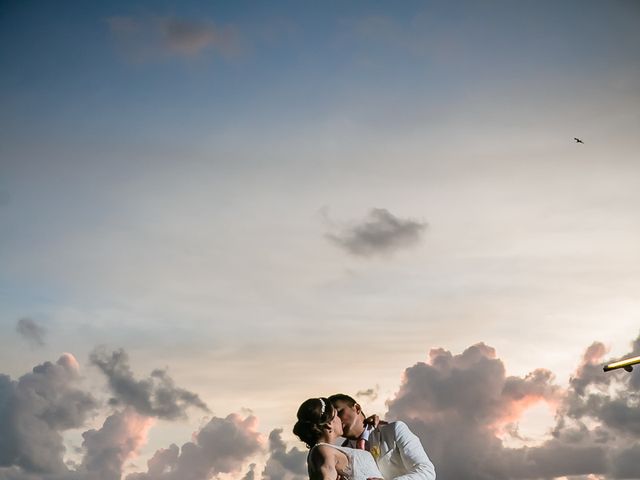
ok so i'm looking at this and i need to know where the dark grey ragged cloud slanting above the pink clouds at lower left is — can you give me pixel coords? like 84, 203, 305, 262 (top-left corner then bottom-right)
90, 348, 209, 420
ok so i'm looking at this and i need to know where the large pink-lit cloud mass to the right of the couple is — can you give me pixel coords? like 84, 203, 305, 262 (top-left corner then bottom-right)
387, 340, 640, 480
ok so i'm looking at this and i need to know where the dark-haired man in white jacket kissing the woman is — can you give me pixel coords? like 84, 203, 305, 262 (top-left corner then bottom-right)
329, 393, 436, 480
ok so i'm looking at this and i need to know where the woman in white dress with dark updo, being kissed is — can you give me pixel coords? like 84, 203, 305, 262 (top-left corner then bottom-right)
293, 397, 382, 480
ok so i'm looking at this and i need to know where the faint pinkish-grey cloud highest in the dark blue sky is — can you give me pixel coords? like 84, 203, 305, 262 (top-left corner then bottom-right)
106, 16, 243, 62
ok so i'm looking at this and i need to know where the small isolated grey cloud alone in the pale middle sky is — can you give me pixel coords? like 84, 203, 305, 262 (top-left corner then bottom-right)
326, 208, 427, 257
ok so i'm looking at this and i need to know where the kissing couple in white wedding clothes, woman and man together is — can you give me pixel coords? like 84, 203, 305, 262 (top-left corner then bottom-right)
293, 393, 436, 480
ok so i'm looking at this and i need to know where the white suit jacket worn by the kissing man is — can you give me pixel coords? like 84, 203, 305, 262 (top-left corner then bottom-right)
348, 421, 436, 480
